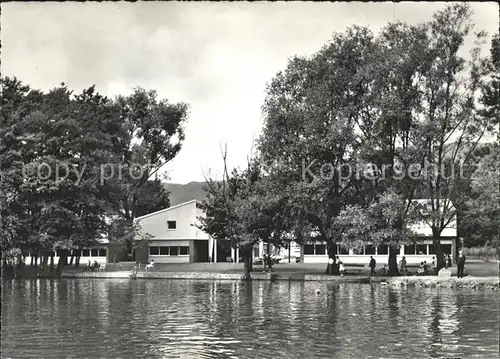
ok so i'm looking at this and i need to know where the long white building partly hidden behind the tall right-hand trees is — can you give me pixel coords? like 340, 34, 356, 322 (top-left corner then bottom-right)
301, 199, 458, 264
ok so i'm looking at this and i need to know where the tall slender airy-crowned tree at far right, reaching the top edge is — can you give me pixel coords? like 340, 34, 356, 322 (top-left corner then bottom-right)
406, 4, 498, 270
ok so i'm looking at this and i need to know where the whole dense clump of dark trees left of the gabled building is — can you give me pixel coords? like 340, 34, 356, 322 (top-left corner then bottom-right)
0, 78, 186, 269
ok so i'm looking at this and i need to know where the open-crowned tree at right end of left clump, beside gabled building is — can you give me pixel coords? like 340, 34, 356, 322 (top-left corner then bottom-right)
105, 88, 188, 260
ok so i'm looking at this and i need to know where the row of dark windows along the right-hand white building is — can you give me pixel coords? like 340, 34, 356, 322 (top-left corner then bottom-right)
304, 244, 451, 255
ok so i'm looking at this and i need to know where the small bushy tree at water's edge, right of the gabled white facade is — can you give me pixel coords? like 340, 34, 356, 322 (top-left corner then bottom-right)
199, 148, 283, 279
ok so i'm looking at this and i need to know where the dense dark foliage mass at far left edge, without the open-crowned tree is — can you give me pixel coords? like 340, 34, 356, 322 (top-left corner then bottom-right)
0, 78, 119, 270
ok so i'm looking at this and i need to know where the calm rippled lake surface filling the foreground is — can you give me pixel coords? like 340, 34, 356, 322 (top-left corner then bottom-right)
2, 279, 499, 359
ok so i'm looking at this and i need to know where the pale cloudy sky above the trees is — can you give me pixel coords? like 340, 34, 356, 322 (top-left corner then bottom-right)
0, 2, 499, 183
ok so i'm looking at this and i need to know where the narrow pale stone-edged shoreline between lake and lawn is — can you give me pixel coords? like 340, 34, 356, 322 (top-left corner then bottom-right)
56, 271, 500, 288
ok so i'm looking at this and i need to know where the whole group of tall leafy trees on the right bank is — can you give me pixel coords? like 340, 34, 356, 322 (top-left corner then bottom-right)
260, 4, 498, 272
